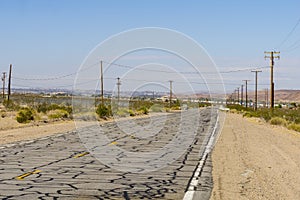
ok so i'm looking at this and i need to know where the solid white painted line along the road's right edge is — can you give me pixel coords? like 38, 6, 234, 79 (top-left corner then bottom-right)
183, 112, 219, 200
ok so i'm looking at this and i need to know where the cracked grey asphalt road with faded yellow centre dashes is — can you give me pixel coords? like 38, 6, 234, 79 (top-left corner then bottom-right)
0, 108, 217, 200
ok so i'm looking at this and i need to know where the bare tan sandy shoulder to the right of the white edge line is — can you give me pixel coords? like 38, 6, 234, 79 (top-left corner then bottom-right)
211, 113, 300, 199
